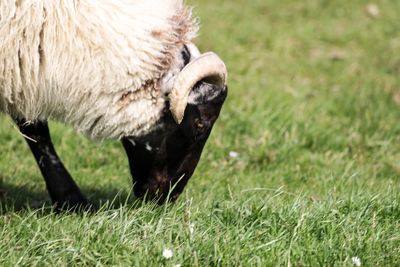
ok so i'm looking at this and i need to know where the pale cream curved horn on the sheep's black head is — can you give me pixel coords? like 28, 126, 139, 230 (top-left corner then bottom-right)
170, 52, 228, 124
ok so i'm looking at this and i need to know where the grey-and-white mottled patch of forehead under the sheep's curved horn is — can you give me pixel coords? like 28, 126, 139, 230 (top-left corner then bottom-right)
188, 81, 227, 105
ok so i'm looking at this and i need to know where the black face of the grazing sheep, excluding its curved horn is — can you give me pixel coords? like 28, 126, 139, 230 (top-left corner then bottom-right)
122, 82, 227, 203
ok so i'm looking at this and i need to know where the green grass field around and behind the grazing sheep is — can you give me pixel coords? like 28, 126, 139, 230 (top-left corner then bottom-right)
0, 0, 400, 266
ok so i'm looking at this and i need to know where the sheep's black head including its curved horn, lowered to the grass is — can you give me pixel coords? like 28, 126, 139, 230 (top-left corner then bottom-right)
122, 53, 227, 203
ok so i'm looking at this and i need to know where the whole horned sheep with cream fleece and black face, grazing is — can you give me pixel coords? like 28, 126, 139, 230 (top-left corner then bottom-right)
0, 0, 227, 209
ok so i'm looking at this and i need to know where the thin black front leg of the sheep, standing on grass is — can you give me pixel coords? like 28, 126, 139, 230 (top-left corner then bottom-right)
16, 120, 91, 210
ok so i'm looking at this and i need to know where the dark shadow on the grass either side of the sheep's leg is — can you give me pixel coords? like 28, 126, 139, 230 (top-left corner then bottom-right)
0, 180, 135, 215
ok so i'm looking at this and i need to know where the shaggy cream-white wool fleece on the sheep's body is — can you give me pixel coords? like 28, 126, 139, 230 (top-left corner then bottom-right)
0, 0, 197, 139
